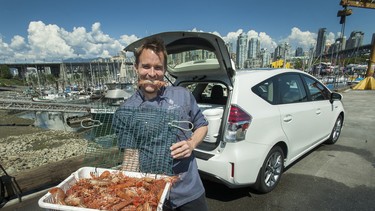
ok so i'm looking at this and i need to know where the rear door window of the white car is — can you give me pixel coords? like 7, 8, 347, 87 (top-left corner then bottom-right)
276, 74, 307, 104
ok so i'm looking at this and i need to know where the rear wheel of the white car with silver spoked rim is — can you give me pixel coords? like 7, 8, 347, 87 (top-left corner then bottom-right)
255, 146, 284, 193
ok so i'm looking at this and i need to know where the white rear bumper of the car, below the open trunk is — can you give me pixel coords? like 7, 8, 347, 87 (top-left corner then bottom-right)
194, 142, 269, 188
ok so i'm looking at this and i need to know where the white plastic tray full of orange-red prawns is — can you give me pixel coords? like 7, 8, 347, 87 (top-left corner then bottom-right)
38, 167, 177, 211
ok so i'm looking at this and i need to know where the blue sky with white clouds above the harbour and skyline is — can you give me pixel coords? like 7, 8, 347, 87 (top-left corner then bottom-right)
0, 0, 375, 63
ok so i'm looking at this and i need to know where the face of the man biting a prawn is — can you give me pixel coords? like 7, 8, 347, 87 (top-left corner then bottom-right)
135, 49, 164, 93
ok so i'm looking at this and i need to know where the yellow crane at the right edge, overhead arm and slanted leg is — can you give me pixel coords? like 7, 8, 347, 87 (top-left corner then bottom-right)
337, 0, 375, 90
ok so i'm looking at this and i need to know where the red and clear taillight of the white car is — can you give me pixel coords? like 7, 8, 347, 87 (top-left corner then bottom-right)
224, 105, 252, 142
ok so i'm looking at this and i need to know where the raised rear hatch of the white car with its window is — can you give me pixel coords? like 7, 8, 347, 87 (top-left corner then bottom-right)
125, 32, 235, 86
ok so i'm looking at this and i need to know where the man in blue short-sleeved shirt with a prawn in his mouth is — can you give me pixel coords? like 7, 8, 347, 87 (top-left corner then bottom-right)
114, 38, 208, 211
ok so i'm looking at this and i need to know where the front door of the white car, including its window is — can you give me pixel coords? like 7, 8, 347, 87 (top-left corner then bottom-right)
302, 75, 336, 143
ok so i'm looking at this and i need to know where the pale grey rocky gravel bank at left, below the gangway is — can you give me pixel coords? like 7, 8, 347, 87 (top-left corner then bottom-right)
0, 130, 87, 175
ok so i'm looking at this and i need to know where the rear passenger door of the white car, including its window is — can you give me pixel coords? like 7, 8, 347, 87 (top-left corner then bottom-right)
276, 73, 315, 162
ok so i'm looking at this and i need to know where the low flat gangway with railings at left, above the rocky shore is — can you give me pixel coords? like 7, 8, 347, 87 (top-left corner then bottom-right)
0, 98, 91, 113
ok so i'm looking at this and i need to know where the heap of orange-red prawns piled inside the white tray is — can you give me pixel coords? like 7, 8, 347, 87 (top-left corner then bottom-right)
49, 171, 177, 210
